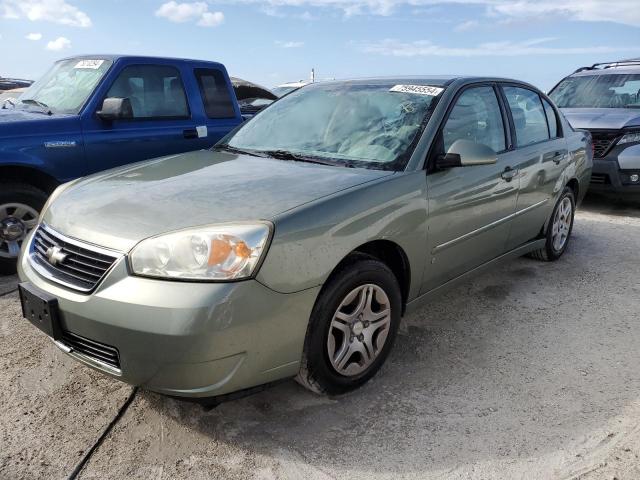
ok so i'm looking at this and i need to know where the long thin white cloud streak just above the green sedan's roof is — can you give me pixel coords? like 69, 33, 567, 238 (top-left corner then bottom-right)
360, 38, 629, 57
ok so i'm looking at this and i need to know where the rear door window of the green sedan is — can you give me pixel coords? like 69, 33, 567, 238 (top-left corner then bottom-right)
504, 86, 557, 147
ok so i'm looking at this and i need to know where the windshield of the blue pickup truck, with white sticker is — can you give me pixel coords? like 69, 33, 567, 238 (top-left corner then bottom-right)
17, 58, 112, 114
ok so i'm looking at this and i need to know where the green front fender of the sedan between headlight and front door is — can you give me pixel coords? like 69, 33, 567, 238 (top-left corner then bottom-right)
257, 171, 427, 299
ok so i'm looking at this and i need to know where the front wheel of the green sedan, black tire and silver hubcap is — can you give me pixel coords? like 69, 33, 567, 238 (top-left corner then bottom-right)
296, 254, 402, 395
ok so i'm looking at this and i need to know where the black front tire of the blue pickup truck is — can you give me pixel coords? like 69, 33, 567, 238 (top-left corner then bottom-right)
0, 183, 47, 275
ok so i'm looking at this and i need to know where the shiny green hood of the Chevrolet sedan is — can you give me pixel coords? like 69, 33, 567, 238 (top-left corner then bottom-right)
44, 150, 393, 252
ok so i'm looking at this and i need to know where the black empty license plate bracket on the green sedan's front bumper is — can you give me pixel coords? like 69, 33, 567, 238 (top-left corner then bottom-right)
18, 282, 62, 340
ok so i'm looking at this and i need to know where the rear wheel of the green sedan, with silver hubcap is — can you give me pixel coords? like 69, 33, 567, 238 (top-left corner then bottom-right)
529, 187, 576, 262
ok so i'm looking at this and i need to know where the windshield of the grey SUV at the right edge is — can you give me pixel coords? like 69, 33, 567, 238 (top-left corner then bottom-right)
549, 73, 640, 108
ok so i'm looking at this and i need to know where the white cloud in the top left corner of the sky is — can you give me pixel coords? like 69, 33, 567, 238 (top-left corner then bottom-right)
0, 0, 91, 28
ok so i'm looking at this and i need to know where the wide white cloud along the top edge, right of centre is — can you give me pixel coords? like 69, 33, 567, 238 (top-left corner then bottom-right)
240, 0, 640, 27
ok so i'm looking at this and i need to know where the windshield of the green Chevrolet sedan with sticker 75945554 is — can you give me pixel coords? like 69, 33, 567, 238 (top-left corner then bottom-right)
226, 83, 443, 170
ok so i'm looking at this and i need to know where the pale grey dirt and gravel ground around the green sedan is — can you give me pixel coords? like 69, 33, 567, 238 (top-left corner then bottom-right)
0, 193, 640, 480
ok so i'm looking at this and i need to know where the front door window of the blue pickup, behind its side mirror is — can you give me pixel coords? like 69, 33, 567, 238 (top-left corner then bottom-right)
107, 65, 190, 120
